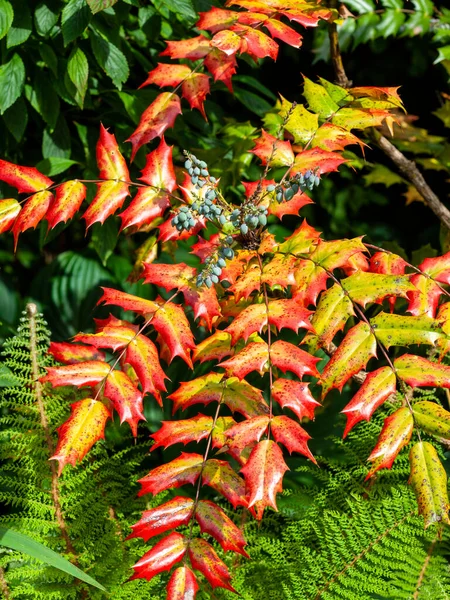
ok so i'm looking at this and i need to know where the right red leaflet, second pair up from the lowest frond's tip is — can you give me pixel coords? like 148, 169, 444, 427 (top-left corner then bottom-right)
195, 500, 250, 558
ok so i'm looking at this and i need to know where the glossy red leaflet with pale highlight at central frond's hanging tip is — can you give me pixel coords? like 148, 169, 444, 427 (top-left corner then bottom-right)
241, 440, 289, 519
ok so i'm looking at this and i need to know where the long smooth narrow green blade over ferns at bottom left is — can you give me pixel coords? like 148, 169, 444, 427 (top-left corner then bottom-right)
0, 526, 106, 591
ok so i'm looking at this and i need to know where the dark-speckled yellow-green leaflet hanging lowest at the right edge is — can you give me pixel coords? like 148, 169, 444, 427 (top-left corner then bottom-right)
409, 442, 450, 528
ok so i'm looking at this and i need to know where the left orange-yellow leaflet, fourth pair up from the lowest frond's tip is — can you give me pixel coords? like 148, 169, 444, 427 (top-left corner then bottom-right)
150, 414, 214, 451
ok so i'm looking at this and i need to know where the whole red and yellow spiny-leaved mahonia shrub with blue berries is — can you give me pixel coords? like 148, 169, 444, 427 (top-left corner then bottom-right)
0, 0, 450, 600
